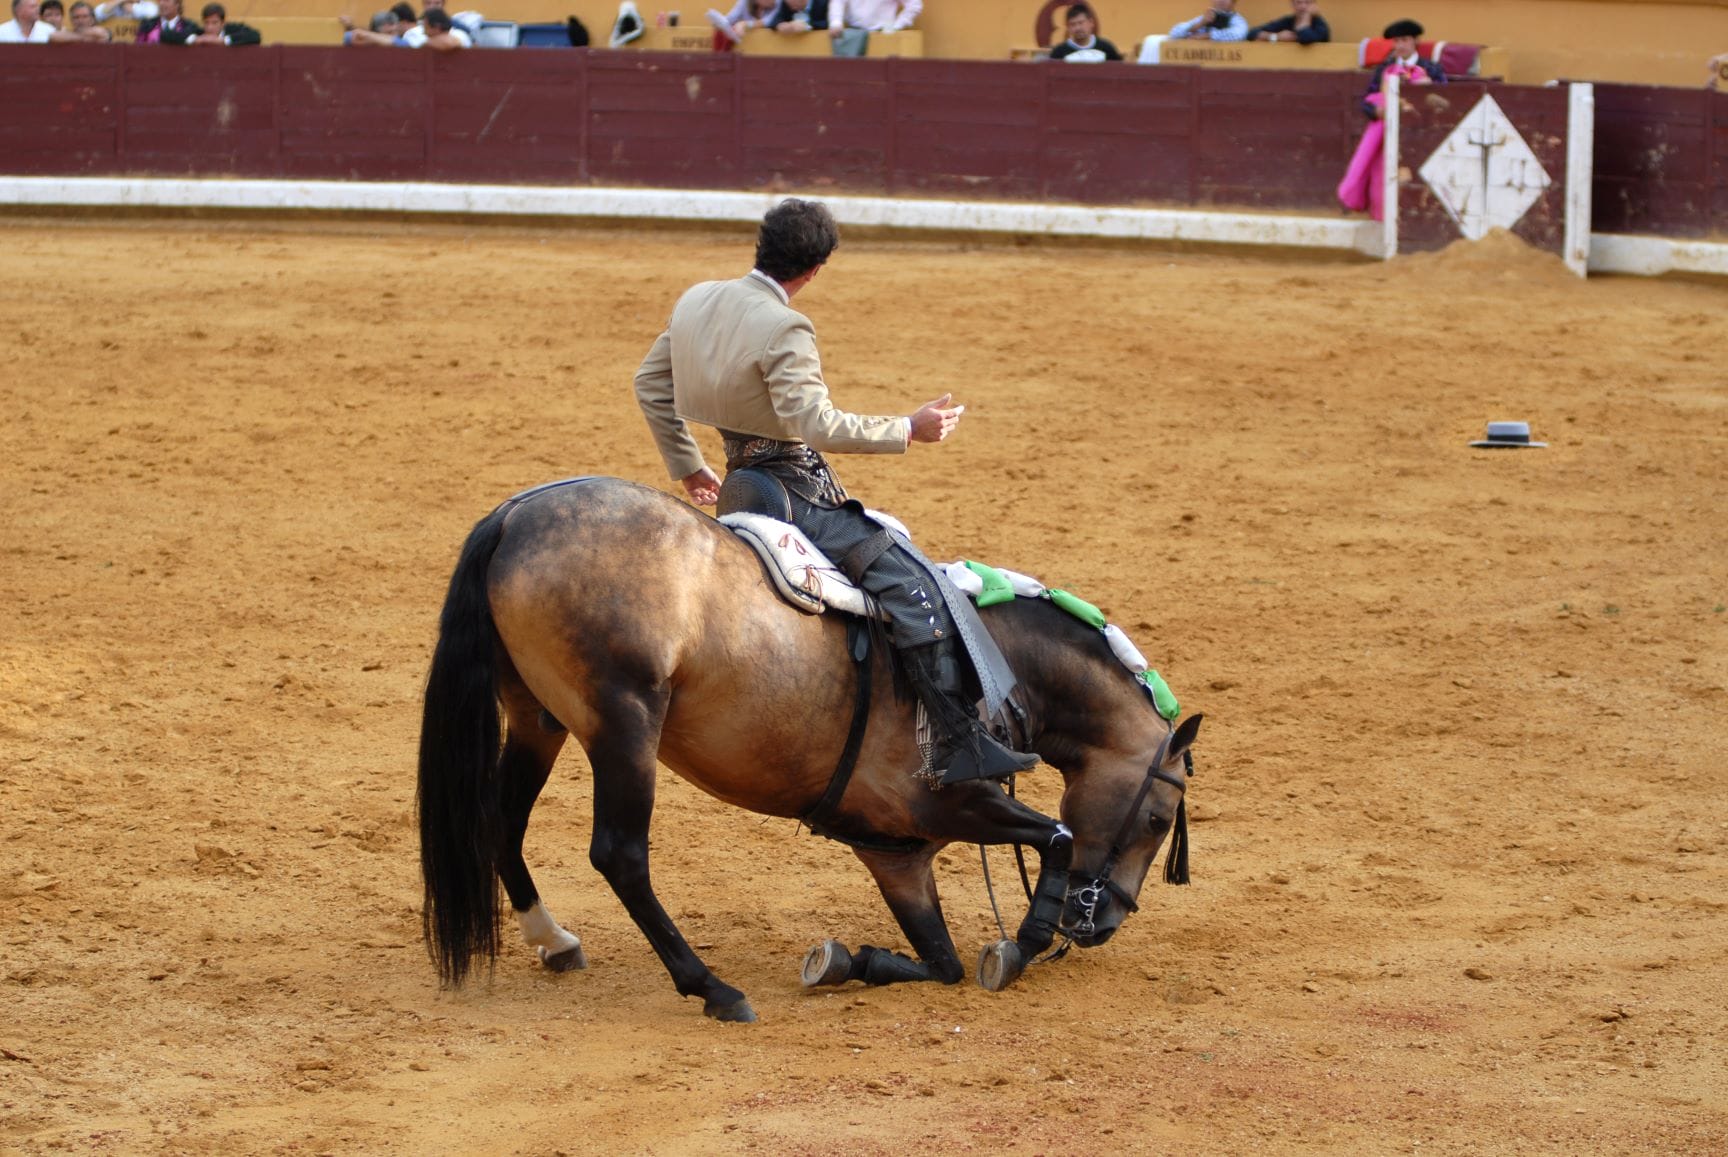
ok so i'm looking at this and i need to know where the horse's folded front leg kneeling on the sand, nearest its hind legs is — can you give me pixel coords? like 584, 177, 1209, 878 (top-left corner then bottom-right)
804, 844, 966, 988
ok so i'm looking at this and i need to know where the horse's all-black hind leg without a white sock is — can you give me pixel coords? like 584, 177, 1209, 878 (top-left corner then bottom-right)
588, 703, 755, 1021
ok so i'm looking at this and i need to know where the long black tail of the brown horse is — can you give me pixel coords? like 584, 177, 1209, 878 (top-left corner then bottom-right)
418, 508, 506, 986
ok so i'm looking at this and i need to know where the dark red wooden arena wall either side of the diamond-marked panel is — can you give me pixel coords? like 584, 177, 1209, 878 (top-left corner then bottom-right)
0, 47, 1728, 238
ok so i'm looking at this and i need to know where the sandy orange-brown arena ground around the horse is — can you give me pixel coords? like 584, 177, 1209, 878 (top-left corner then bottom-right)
0, 219, 1728, 1154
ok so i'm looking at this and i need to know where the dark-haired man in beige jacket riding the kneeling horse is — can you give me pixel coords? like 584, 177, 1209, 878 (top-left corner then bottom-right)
636, 199, 1037, 784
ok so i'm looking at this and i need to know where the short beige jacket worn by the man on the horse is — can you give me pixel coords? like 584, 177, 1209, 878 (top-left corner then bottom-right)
636, 271, 912, 478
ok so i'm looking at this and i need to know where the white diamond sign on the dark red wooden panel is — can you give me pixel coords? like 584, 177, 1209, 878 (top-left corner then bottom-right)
1420, 97, 1553, 242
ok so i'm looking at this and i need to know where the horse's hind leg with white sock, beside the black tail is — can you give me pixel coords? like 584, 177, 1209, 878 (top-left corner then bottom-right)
498, 684, 588, 972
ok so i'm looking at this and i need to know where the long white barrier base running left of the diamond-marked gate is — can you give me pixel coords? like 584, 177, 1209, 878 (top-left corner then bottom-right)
0, 176, 1379, 256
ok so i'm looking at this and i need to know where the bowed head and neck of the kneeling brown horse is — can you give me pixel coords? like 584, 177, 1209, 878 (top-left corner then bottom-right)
997, 599, 1201, 948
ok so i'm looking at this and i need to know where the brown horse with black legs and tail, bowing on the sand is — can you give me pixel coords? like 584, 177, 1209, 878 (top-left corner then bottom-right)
418, 478, 1199, 1021
